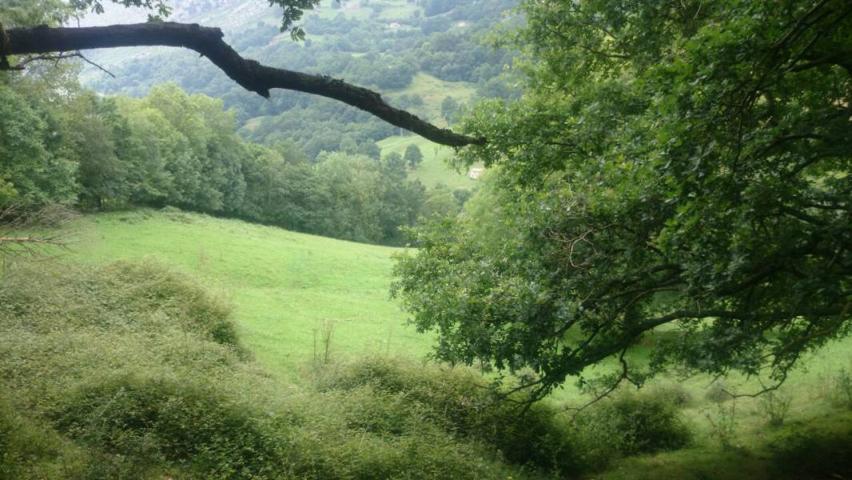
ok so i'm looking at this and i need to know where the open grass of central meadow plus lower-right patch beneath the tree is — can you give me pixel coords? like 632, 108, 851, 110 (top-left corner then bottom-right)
48, 210, 852, 479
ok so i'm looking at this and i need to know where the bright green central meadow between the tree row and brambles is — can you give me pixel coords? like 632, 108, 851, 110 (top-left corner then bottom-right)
65, 210, 430, 380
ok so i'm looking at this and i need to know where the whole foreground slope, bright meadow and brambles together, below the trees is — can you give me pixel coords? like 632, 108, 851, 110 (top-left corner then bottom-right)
0, 209, 852, 480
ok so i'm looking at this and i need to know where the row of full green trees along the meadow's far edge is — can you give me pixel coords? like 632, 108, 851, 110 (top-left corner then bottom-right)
0, 68, 460, 244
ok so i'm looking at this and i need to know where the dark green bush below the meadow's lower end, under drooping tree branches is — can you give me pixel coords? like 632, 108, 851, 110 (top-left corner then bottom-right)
320, 358, 580, 473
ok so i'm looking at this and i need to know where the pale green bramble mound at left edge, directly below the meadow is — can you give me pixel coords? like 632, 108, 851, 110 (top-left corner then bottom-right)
0, 261, 245, 354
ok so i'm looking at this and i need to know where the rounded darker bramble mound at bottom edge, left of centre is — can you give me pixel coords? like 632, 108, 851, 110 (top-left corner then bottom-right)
53, 376, 289, 478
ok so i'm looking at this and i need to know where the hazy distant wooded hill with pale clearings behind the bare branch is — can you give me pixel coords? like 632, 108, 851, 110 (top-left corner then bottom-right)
83, 0, 516, 175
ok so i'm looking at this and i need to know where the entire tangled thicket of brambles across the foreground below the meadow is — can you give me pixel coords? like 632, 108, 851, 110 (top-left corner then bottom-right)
0, 262, 686, 479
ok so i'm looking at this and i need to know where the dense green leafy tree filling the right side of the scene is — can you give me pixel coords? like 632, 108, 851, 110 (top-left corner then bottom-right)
396, 0, 852, 394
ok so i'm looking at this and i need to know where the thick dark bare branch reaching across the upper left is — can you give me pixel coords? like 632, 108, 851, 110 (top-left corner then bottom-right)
0, 22, 483, 147
